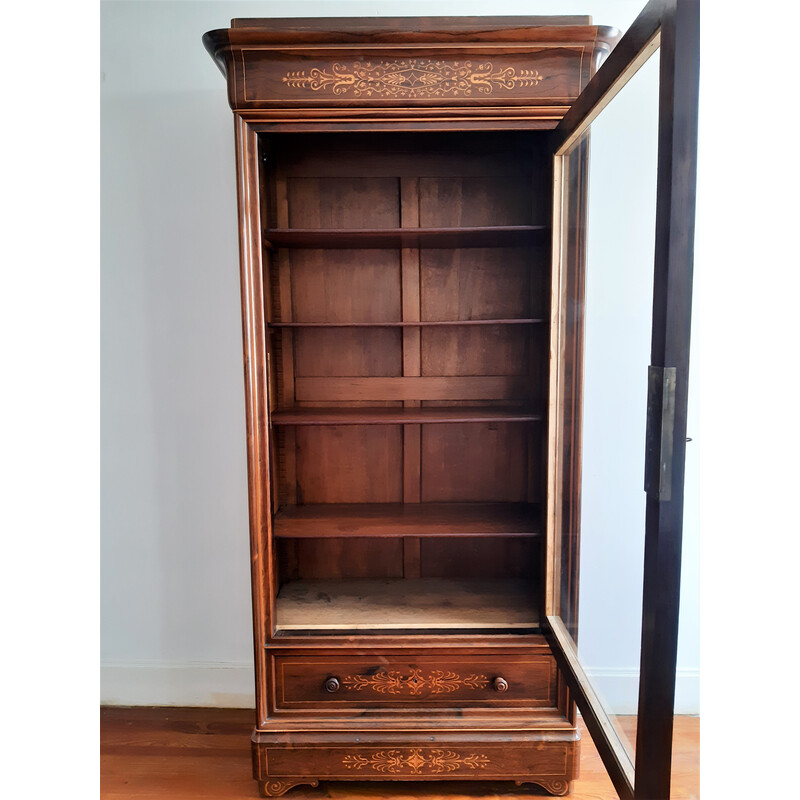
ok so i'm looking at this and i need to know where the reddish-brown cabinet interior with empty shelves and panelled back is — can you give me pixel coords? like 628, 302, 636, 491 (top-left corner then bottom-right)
259, 131, 551, 635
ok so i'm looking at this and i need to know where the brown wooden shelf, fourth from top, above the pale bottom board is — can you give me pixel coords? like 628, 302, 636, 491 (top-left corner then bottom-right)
272, 503, 540, 539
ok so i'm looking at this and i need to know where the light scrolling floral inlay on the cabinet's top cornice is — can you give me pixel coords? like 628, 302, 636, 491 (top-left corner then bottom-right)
283, 58, 543, 99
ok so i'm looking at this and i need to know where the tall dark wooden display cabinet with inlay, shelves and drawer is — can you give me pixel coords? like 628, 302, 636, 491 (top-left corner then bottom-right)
204, 4, 688, 796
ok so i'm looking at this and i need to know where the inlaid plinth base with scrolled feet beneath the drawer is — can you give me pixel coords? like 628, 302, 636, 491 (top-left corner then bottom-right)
253, 728, 580, 797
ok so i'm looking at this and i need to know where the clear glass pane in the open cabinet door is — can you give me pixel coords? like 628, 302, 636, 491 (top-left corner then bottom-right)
578, 47, 659, 760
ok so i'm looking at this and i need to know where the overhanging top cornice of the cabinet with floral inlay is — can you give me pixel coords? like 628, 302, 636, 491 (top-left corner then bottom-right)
205, 17, 615, 115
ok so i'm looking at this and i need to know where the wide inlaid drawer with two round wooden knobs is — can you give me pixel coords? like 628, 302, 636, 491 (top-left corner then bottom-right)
273, 654, 556, 711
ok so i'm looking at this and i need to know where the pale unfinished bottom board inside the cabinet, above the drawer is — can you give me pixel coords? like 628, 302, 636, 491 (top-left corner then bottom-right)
276, 578, 539, 633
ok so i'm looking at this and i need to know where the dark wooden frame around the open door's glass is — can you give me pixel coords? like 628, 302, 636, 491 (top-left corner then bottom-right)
544, 0, 699, 800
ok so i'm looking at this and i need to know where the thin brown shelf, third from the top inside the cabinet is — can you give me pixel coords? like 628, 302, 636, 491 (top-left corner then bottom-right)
270, 406, 544, 425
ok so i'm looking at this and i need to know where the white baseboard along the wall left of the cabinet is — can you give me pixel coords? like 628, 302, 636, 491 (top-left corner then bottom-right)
100, 661, 255, 708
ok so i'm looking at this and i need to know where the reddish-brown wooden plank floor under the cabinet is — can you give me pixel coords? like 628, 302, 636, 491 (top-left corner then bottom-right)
100, 708, 700, 800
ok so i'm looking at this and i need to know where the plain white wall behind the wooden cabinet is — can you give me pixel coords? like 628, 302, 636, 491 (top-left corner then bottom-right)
101, 0, 699, 712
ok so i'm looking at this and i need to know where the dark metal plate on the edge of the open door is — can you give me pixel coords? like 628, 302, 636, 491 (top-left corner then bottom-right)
644, 366, 677, 500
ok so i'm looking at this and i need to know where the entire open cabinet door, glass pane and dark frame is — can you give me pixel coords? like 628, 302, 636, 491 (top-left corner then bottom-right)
545, 0, 699, 800
